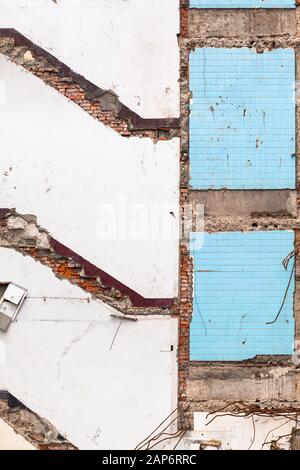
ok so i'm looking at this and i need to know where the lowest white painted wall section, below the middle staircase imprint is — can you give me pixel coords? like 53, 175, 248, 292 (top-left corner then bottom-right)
0, 248, 177, 449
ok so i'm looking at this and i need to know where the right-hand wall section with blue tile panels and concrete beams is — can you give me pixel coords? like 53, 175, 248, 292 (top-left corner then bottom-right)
179, 0, 300, 450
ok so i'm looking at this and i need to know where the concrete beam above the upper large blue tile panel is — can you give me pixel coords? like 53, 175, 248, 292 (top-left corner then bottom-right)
189, 9, 297, 38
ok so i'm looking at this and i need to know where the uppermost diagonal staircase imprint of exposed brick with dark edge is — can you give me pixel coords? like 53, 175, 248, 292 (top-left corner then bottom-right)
0, 29, 179, 140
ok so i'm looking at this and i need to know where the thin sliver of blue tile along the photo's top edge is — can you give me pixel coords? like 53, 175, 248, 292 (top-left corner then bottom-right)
190, 0, 295, 8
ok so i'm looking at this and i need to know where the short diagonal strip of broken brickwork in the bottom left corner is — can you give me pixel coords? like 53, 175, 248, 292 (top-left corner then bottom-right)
0, 390, 78, 450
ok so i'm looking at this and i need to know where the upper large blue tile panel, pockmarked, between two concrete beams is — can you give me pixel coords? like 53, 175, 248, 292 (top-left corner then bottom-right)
190, 48, 295, 189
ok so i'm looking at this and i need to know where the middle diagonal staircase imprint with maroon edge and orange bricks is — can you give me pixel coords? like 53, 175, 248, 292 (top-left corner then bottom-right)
0, 209, 175, 314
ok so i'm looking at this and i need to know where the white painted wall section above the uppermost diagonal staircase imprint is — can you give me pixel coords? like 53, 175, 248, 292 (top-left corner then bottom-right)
0, 0, 179, 118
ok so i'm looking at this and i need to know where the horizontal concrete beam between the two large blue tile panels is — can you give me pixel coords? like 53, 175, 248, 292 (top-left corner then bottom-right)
190, 190, 297, 217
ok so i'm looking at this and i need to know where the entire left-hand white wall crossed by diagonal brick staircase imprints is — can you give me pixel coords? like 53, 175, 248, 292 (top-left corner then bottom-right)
0, 0, 179, 450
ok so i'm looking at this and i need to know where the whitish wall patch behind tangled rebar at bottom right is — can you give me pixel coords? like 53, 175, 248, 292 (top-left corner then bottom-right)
182, 412, 295, 450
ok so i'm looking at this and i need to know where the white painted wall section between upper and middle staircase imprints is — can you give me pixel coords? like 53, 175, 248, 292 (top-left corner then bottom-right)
0, 55, 179, 297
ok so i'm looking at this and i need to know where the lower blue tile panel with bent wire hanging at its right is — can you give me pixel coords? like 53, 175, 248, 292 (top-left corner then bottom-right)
190, 231, 294, 361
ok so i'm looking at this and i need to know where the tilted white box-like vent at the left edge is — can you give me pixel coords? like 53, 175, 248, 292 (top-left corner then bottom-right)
0, 282, 27, 331
